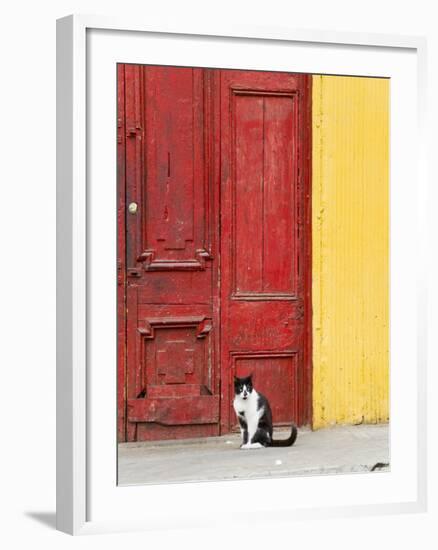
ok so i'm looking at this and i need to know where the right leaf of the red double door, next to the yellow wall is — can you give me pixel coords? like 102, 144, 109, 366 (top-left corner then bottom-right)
221, 71, 311, 430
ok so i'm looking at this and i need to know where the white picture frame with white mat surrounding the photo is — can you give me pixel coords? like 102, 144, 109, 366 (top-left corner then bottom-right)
57, 15, 427, 534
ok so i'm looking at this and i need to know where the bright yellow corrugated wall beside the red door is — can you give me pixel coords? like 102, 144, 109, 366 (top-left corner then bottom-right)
312, 76, 389, 428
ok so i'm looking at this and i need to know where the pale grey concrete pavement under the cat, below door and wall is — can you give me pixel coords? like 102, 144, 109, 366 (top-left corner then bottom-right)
118, 424, 389, 485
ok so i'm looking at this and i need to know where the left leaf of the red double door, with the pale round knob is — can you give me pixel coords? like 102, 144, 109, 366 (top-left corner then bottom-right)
120, 65, 219, 441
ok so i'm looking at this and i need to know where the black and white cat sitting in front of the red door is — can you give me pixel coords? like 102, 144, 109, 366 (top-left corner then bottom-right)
233, 376, 297, 449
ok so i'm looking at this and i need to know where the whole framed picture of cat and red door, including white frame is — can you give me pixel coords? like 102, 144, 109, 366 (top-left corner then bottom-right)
57, 16, 426, 534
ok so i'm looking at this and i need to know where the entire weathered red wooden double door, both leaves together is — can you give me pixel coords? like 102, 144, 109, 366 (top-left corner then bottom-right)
118, 65, 310, 441
